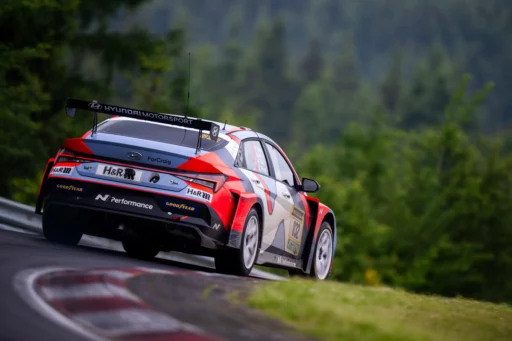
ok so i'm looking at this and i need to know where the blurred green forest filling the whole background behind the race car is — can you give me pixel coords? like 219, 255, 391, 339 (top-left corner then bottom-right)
0, 0, 512, 302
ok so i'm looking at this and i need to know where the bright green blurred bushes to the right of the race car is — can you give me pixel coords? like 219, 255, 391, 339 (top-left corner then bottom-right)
301, 78, 512, 301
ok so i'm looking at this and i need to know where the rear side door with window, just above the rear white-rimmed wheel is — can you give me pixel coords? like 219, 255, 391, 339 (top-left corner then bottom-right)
239, 139, 288, 252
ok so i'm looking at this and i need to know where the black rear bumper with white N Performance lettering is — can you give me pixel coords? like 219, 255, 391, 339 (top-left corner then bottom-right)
41, 178, 229, 249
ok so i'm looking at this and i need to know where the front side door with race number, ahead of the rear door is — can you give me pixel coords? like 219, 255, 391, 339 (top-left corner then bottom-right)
265, 142, 309, 258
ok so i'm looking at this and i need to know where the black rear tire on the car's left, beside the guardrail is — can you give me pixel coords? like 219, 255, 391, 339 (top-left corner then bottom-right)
42, 207, 83, 245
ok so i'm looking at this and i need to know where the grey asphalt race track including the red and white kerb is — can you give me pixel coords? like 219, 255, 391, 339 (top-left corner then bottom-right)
0, 228, 316, 341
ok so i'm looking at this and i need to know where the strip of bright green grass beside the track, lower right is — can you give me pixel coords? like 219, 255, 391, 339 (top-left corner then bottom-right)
248, 279, 512, 341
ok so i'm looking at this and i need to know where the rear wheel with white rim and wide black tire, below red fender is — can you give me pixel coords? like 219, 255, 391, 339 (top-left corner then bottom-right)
215, 208, 260, 276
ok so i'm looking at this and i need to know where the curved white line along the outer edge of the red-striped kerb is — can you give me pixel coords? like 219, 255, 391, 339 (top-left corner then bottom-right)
13, 268, 108, 341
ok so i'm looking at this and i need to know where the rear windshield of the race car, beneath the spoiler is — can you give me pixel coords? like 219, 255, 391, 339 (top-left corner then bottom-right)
98, 120, 227, 151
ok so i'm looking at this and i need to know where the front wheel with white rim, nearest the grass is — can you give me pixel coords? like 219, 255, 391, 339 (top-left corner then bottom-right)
310, 221, 334, 281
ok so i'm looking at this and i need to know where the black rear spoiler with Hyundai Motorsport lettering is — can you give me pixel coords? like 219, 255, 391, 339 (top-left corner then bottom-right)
66, 98, 220, 153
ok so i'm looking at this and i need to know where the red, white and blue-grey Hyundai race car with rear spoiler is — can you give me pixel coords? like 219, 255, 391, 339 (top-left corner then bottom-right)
36, 99, 336, 280
